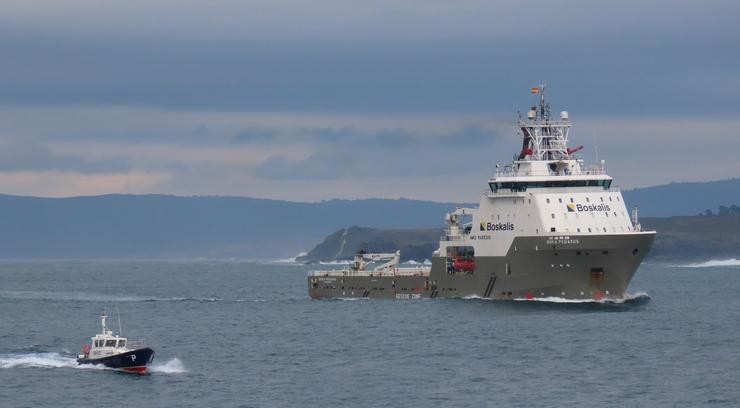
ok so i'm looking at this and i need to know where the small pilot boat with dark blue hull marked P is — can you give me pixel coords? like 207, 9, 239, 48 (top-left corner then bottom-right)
77, 313, 154, 374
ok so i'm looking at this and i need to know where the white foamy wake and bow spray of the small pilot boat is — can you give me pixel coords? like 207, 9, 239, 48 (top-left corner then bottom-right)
0, 352, 188, 374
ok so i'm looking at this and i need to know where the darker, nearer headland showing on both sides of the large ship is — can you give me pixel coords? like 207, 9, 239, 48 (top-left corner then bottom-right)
298, 214, 740, 263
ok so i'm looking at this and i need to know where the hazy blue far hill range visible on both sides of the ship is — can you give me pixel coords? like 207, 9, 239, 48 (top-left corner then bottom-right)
0, 179, 740, 259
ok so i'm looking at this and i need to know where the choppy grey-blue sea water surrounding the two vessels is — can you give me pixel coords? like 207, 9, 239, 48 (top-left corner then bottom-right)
0, 261, 740, 407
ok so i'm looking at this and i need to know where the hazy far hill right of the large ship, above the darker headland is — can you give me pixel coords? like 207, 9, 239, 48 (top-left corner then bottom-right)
622, 178, 740, 217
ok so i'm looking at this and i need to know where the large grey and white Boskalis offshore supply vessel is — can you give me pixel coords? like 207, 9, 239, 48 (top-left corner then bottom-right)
308, 86, 655, 300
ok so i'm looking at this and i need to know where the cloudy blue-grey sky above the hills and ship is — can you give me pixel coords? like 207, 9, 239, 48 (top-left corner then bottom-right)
0, 0, 740, 201
